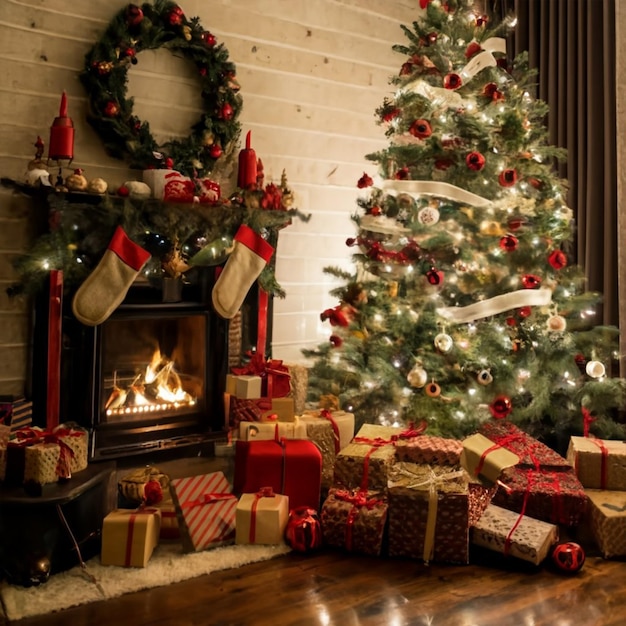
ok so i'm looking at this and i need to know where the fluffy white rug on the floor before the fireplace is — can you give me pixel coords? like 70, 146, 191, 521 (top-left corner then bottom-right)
0, 542, 291, 620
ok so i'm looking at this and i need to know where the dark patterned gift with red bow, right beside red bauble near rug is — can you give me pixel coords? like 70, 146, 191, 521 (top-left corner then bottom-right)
320, 488, 387, 556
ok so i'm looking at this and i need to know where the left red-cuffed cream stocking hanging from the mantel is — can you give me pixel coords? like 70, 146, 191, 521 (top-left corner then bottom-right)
72, 226, 150, 326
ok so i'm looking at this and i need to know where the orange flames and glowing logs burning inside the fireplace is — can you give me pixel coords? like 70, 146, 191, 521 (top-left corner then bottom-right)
105, 350, 196, 416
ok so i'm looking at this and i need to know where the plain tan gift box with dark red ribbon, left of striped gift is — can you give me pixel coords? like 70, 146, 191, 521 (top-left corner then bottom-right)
100, 508, 161, 567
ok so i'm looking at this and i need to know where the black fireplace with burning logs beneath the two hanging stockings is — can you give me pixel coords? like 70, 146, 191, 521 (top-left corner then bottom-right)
32, 272, 234, 461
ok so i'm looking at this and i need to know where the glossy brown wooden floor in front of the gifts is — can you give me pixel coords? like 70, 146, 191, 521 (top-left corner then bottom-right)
4, 536, 626, 626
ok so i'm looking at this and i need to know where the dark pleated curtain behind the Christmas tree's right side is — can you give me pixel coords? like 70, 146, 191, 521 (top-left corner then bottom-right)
491, 0, 619, 326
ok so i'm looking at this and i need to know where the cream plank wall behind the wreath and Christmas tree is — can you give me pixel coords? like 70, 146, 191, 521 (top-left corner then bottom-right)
0, 0, 419, 394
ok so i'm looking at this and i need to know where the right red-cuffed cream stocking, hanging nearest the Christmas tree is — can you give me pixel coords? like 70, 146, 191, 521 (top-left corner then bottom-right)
212, 224, 274, 319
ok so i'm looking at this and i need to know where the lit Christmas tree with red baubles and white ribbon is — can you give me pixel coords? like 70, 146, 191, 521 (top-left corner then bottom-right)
304, 0, 624, 447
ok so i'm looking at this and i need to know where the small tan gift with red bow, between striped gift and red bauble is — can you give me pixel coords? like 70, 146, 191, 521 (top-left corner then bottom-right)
235, 488, 289, 544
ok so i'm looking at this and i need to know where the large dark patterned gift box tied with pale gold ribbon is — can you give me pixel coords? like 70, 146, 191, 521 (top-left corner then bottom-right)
387, 462, 469, 564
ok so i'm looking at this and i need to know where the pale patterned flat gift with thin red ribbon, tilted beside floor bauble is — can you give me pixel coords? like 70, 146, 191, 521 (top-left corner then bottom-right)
470, 504, 559, 565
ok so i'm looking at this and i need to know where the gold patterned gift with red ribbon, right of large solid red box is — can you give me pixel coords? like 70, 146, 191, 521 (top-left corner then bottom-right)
334, 424, 404, 490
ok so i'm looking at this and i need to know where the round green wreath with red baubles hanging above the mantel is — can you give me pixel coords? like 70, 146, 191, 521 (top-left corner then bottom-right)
80, 0, 241, 177
